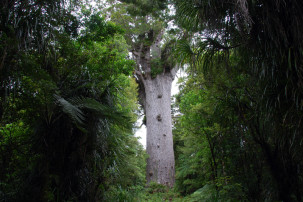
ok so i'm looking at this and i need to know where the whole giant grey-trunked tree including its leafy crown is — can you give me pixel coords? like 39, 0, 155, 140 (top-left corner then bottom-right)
111, 1, 177, 187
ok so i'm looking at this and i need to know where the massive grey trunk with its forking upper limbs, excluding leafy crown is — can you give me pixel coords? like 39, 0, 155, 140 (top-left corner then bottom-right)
133, 30, 177, 187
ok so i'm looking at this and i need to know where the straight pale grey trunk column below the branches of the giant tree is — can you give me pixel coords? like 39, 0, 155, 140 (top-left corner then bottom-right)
145, 73, 175, 187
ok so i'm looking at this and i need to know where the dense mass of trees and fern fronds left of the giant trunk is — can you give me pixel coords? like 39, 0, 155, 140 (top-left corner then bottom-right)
0, 1, 145, 201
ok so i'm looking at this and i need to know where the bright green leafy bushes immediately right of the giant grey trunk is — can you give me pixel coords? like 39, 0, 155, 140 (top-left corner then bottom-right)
174, 56, 267, 201
